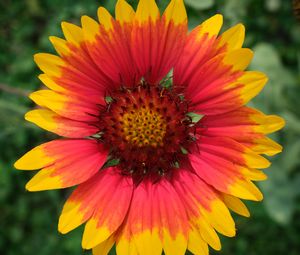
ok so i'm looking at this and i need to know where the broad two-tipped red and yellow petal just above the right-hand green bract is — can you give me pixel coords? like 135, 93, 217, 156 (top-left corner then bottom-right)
185, 49, 256, 115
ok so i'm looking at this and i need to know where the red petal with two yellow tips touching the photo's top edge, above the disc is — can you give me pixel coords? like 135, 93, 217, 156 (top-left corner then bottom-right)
131, 0, 187, 84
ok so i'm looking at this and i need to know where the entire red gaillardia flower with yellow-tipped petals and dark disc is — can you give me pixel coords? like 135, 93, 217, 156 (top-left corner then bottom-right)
15, 0, 284, 255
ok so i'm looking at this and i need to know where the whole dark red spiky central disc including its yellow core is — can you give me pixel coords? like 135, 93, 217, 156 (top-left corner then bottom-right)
100, 84, 194, 177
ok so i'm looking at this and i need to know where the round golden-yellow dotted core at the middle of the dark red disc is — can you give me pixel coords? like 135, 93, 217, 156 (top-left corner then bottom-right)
121, 105, 167, 147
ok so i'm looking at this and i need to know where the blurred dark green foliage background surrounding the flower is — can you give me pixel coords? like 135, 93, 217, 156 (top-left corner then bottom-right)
0, 0, 300, 255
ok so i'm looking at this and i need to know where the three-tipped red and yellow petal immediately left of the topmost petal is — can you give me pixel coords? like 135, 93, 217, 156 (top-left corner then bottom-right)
82, 5, 140, 90
